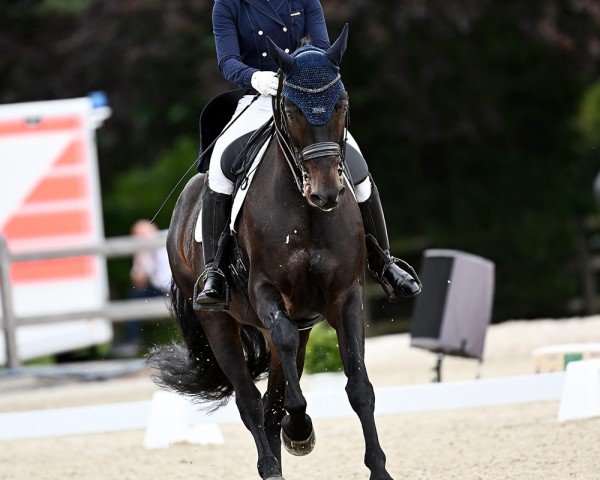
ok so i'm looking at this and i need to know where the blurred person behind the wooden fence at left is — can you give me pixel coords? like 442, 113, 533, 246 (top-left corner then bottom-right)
111, 219, 171, 358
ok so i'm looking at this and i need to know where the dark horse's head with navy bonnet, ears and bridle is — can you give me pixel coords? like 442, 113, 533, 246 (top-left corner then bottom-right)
268, 25, 348, 211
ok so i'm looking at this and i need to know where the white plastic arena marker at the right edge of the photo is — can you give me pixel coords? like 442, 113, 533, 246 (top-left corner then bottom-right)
558, 360, 600, 421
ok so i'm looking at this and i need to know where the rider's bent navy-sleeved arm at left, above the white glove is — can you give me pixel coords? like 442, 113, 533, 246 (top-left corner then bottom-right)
212, 1, 258, 87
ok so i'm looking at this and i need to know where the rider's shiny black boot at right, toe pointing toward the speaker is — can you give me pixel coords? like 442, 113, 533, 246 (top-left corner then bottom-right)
358, 179, 421, 301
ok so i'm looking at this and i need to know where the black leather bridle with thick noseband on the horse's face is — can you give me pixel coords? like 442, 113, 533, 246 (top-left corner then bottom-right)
273, 70, 352, 196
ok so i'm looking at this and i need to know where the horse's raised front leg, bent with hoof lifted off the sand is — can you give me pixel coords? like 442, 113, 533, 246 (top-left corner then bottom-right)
253, 283, 314, 455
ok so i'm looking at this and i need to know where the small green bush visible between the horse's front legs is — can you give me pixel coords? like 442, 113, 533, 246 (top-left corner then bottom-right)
304, 323, 342, 373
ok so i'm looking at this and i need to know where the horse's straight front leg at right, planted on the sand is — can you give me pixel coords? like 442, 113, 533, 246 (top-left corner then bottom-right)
328, 286, 392, 480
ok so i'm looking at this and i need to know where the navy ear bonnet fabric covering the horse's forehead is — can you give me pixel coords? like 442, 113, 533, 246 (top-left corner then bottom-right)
283, 45, 344, 125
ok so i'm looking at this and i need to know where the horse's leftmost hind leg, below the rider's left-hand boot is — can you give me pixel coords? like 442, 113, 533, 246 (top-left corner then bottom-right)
197, 313, 282, 480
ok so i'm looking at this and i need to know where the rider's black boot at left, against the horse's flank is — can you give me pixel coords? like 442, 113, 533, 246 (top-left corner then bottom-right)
194, 186, 231, 310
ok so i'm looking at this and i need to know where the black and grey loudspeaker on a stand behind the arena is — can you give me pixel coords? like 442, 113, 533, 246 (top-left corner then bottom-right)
410, 249, 494, 382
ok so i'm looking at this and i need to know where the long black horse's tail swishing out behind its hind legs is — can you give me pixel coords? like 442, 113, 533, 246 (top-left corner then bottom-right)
146, 282, 271, 410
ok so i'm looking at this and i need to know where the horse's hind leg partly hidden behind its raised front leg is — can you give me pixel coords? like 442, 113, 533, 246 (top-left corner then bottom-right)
263, 331, 309, 464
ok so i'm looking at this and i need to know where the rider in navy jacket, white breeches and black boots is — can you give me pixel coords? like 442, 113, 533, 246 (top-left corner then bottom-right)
195, 0, 421, 309
